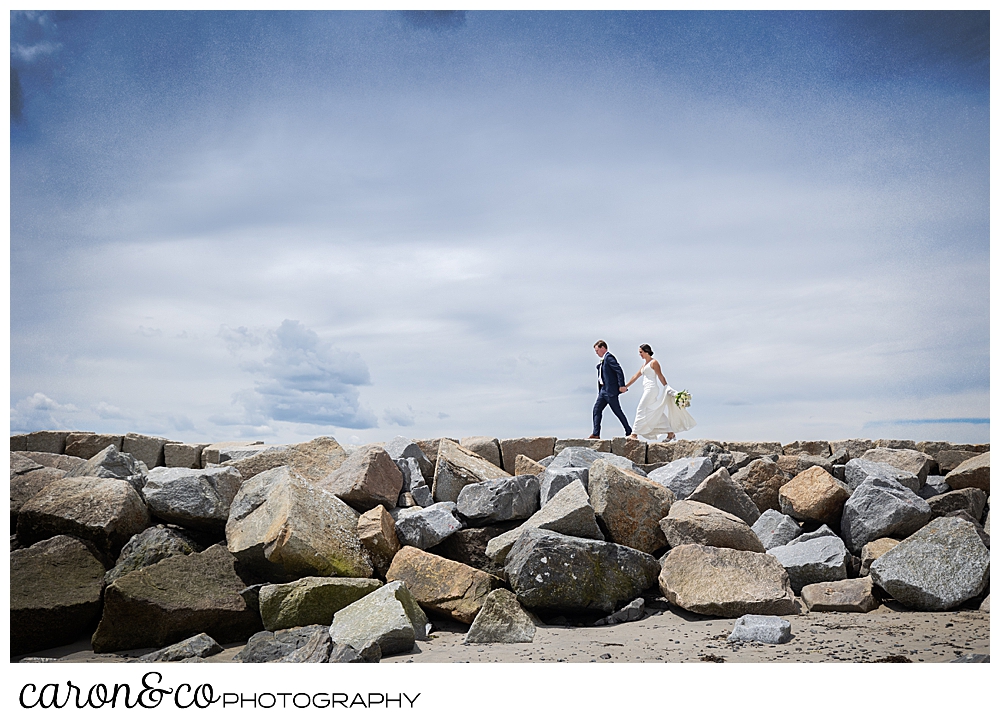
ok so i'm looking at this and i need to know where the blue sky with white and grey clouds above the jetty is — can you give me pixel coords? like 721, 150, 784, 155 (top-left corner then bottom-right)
10, 12, 989, 443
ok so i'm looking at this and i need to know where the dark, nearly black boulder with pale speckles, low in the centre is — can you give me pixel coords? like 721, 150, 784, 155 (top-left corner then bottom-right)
504, 529, 659, 613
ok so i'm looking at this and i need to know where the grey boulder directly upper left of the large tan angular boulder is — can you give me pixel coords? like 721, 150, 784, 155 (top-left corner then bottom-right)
142, 467, 243, 532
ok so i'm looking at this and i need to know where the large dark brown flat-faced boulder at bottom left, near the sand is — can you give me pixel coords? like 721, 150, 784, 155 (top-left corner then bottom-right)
91, 545, 260, 653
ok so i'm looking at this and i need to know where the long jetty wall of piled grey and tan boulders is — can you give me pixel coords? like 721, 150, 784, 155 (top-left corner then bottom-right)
10, 431, 990, 662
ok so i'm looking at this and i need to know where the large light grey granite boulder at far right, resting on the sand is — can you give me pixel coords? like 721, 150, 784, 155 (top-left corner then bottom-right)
871, 517, 990, 610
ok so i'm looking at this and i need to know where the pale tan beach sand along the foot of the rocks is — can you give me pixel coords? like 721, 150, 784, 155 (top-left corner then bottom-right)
11, 602, 990, 664
